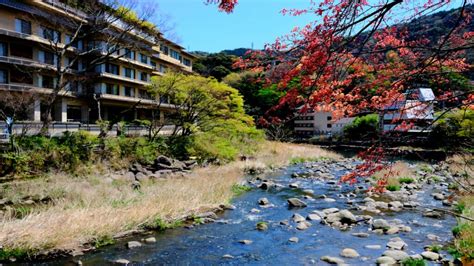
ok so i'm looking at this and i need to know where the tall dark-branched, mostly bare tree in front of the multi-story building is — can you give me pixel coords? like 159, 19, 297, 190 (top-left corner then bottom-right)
24, 0, 159, 134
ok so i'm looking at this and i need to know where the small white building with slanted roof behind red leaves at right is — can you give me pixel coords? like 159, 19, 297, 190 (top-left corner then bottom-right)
381, 88, 435, 132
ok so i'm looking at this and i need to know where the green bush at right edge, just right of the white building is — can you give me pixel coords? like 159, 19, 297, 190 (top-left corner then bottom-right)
430, 109, 474, 147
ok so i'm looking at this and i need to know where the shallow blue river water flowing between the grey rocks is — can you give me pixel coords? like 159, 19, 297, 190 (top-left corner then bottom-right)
47, 161, 456, 265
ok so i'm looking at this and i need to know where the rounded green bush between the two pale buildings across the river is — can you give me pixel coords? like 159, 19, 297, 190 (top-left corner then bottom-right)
344, 114, 380, 140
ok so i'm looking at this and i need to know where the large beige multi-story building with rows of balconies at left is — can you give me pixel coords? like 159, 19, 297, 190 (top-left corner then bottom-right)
0, 0, 195, 123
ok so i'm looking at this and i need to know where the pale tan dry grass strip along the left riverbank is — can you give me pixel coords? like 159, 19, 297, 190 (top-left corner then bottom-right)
0, 142, 337, 255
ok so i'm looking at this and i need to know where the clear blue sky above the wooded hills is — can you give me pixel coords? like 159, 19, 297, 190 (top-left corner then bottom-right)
146, 0, 310, 52
